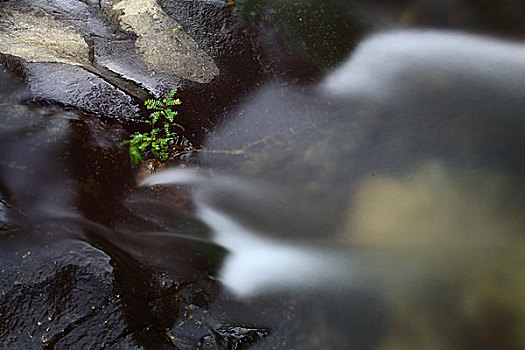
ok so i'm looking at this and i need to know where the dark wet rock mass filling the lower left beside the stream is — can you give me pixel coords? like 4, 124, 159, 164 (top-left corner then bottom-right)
0, 72, 328, 349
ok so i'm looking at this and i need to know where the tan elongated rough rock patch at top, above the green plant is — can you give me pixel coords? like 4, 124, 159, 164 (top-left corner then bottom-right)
111, 0, 219, 83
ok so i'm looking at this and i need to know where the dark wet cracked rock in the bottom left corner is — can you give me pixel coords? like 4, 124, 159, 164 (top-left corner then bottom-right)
0, 239, 124, 349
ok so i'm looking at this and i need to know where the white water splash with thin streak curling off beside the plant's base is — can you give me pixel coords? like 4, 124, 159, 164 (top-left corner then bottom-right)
141, 169, 355, 297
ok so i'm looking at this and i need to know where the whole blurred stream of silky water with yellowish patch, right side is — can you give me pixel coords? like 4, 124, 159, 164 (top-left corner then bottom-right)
146, 31, 525, 349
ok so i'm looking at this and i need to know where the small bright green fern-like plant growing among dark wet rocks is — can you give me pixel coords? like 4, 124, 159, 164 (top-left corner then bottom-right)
123, 89, 184, 166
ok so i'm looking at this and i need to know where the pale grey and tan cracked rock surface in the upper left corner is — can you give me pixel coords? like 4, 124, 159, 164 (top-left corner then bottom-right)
0, 1, 219, 121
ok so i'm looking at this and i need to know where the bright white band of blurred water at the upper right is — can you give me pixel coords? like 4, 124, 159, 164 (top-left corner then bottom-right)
321, 30, 525, 103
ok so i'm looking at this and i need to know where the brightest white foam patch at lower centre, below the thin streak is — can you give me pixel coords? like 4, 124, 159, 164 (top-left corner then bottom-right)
198, 206, 351, 297
